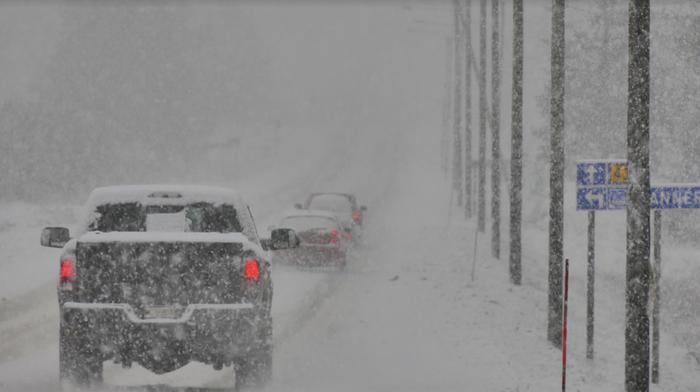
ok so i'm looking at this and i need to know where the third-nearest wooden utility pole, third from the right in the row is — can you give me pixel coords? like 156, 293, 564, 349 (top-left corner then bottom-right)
509, 0, 523, 285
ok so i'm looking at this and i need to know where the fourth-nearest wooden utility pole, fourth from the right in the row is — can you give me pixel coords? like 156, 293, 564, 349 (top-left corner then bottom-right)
491, 0, 501, 259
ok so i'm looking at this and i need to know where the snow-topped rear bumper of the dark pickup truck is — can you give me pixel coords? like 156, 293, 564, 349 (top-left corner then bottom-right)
61, 302, 272, 373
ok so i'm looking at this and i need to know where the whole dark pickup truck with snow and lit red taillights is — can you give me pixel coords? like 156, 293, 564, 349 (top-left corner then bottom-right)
41, 185, 299, 387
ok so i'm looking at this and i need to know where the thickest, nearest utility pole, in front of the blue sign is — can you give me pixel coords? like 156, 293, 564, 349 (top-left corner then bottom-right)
625, 0, 651, 392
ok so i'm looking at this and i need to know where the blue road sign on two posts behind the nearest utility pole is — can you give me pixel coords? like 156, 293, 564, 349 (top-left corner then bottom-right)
576, 159, 700, 384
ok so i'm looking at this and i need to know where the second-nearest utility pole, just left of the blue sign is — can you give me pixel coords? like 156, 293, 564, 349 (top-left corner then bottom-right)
547, 0, 565, 347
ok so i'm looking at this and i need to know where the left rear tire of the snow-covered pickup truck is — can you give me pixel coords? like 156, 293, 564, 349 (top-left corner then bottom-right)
59, 315, 103, 390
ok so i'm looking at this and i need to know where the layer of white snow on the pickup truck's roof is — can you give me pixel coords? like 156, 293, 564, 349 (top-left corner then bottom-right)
87, 184, 245, 207
